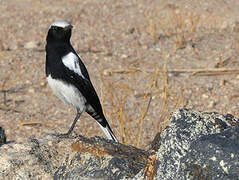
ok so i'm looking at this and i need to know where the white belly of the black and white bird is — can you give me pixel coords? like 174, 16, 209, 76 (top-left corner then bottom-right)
47, 75, 86, 112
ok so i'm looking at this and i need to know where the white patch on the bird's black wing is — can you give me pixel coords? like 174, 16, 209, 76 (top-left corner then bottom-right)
62, 52, 85, 79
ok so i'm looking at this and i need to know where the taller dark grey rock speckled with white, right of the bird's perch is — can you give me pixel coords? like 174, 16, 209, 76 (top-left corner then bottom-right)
134, 109, 239, 180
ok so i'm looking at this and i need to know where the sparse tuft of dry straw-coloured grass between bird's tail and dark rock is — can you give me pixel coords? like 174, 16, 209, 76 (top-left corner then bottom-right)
101, 57, 184, 148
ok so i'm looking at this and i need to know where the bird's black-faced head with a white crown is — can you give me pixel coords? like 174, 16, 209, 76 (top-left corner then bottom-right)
47, 21, 73, 42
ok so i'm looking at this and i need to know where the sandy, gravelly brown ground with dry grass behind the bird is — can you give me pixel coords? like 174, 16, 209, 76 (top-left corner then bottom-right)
0, 0, 239, 149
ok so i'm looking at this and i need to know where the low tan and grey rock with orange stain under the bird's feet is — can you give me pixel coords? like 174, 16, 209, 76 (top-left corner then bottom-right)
0, 136, 148, 179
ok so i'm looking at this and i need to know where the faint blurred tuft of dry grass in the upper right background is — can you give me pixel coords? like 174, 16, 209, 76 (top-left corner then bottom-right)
145, 6, 200, 50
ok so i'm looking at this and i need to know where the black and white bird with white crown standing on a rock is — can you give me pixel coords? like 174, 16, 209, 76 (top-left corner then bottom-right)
46, 21, 118, 142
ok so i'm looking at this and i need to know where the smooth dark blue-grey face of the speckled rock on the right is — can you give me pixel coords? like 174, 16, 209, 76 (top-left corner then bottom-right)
179, 127, 239, 180
